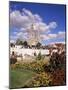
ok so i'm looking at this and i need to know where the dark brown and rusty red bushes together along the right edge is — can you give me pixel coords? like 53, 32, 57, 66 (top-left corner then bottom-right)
43, 52, 66, 86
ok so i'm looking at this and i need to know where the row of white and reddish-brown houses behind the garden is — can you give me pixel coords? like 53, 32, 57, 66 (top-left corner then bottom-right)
10, 44, 65, 59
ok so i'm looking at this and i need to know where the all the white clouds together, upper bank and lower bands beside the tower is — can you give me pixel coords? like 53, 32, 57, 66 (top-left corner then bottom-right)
10, 8, 65, 43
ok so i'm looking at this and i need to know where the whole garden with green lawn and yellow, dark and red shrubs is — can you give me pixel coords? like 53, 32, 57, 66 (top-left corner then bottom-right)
10, 52, 66, 88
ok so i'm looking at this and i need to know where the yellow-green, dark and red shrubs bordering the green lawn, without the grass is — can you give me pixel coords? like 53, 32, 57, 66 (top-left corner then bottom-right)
12, 52, 66, 87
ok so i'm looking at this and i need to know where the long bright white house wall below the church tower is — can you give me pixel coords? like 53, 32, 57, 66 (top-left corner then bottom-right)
10, 47, 49, 58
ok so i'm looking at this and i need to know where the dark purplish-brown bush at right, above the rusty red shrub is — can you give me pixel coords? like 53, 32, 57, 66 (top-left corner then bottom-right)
50, 52, 66, 71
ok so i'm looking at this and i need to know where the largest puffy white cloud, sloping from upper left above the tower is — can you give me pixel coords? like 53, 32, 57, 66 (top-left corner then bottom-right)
10, 8, 57, 31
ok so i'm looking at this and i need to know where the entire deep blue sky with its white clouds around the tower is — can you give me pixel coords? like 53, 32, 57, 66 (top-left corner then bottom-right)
9, 1, 66, 44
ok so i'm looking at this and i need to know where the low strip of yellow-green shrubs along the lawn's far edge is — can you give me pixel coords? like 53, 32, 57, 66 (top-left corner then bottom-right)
11, 60, 47, 73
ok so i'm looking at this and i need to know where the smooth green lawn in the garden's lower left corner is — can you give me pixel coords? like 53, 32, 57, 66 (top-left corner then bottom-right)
10, 70, 35, 88
